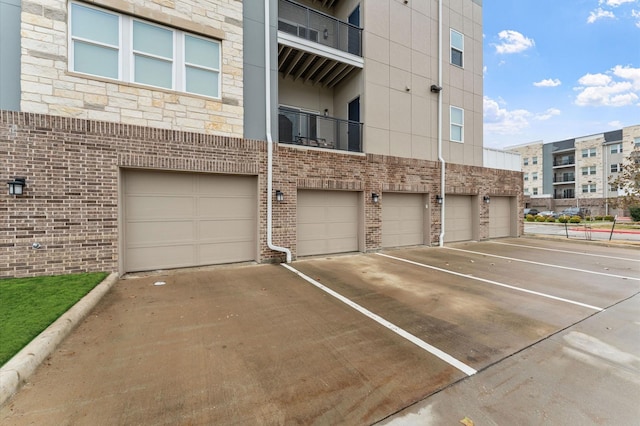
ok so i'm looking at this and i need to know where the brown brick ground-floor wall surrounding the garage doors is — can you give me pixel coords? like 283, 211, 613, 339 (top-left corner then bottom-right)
0, 111, 524, 277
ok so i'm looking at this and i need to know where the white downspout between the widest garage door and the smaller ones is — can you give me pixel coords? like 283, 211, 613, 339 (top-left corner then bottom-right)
264, 0, 291, 263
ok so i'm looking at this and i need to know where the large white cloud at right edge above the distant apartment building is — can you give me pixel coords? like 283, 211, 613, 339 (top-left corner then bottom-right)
574, 65, 640, 107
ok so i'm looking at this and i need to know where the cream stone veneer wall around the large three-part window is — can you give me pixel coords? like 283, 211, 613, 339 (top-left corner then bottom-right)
20, 0, 244, 137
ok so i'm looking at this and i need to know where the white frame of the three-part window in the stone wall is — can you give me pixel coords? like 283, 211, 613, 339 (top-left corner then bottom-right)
67, 2, 222, 99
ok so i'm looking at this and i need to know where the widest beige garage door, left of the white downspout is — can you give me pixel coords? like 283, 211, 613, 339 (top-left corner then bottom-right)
123, 171, 257, 272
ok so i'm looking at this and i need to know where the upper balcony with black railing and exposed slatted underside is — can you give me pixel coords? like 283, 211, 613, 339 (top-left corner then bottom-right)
278, 0, 364, 88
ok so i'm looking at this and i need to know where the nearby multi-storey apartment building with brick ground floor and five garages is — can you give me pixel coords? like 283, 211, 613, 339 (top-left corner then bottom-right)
0, 0, 523, 276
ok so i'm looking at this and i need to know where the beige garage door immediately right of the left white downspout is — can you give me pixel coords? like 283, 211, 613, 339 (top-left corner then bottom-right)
298, 191, 359, 256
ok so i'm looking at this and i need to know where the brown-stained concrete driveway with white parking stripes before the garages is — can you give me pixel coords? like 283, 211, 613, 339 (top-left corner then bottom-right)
0, 238, 640, 425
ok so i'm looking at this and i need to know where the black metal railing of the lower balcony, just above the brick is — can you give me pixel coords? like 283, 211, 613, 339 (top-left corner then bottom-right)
278, 107, 362, 152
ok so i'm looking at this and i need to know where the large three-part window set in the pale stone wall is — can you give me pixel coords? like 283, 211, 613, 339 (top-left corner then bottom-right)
69, 3, 221, 98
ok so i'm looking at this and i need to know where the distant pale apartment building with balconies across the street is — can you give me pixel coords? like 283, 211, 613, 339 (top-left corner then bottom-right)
505, 125, 640, 215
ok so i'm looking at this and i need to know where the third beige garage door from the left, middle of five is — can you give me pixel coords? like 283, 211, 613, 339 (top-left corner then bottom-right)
382, 192, 424, 247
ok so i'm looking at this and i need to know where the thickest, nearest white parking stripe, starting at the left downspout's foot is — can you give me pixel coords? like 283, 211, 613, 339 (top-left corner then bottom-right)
281, 263, 477, 376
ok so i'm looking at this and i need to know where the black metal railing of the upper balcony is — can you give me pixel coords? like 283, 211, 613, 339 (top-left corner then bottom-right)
278, 0, 362, 56
